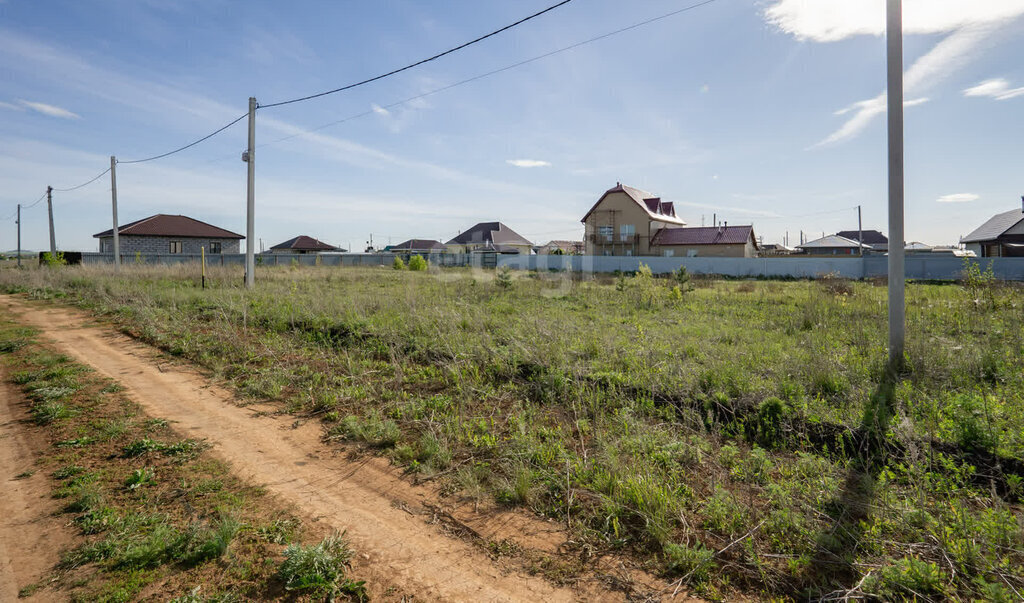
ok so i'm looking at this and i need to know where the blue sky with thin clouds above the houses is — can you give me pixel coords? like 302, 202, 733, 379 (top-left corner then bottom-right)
0, 0, 1024, 250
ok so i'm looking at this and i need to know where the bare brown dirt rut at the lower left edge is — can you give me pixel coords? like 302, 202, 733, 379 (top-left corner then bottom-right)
0, 381, 75, 601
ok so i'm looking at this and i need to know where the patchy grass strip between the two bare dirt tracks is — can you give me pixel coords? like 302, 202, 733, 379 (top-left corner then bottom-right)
0, 318, 361, 603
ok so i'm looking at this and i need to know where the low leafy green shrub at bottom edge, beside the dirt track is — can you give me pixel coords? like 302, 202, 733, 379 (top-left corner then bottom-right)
278, 533, 367, 601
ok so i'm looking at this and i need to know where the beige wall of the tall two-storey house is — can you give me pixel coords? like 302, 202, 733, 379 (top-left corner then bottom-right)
584, 192, 677, 256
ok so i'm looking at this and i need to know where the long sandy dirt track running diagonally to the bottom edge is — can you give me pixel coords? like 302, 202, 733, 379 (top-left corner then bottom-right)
0, 296, 671, 602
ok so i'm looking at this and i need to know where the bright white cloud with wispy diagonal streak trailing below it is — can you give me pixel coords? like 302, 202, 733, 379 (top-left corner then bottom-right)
764, 0, 1024, 148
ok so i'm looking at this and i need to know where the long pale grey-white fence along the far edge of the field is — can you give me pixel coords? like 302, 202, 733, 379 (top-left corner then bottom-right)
75, 253, 1024, 281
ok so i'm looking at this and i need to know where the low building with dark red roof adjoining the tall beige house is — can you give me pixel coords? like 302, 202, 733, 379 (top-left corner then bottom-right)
650, 225, 759, 258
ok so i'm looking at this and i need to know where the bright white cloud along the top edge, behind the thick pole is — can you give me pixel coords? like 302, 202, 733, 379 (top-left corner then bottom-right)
764, 0, 1024, 42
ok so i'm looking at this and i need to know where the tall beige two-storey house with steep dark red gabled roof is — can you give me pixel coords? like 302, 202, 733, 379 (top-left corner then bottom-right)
581, 182, 686, 256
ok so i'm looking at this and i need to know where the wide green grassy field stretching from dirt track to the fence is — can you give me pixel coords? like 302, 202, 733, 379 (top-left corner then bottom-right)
0, 266, 1024, 601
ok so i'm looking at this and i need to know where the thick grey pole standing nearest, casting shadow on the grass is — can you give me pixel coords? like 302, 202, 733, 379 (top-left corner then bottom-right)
886, 0, 906, 368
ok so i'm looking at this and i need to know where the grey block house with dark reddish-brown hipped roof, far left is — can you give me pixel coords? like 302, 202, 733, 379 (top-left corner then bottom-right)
92, 214, 245, 254
